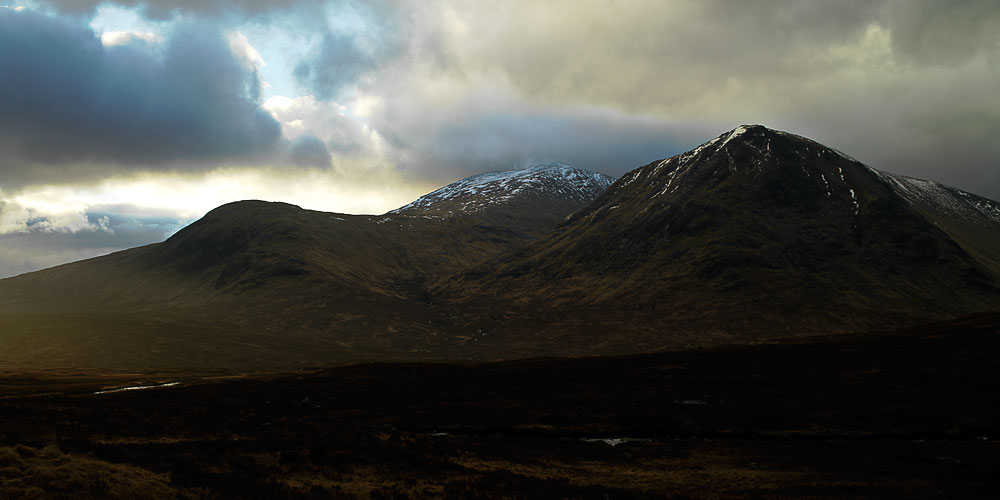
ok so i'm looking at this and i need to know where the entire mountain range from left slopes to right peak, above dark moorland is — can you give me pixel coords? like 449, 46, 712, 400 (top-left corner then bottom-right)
0, 125, 1000, 370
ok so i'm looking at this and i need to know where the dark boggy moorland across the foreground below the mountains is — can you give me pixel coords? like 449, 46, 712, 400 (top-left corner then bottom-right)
0, 314, 1000, 499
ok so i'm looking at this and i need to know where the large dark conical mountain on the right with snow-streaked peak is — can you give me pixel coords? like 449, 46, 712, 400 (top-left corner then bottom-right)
434, 125, 1000, 354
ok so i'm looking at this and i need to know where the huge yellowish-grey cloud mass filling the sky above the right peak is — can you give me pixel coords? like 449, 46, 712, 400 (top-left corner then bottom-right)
317, 0, 1000, 198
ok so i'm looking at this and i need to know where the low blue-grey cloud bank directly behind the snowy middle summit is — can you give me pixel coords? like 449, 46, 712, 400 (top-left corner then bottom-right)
386, 105, 719, 182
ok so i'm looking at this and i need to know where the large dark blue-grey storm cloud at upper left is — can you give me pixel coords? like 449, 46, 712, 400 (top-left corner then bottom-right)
0, 9, 281, 183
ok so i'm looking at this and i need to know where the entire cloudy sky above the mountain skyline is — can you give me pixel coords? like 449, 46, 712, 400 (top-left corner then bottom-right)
0, 0, 1000, 277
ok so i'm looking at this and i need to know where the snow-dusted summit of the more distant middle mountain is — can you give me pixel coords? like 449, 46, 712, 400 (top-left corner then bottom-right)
390, 163, 615, 216
